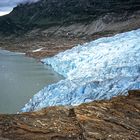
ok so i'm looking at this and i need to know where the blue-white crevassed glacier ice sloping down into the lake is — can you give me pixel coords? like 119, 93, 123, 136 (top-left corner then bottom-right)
21, 29, 140, 112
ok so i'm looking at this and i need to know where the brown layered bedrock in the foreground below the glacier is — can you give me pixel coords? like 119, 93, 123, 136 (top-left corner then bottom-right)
0, 91, 140, 140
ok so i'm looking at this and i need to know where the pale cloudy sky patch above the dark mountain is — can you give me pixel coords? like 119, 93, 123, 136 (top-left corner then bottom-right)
0, 0, 38, 16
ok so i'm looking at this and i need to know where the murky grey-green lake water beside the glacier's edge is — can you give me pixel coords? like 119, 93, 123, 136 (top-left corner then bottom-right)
0, 50, 63, 113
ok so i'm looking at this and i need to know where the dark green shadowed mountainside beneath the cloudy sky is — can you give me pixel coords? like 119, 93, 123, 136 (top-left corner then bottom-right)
0, 0, 140, 35
